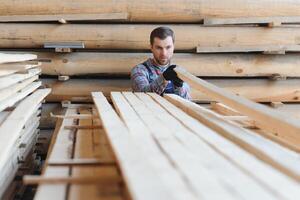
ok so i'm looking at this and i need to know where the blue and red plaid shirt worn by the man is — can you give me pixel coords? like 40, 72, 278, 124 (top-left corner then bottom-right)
131, 58, 191, 99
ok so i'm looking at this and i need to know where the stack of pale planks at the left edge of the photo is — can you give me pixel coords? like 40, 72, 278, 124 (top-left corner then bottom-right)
0, 54, 50, 199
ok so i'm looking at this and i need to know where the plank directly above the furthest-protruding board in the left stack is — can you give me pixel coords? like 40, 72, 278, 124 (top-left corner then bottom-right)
0, 82, 41, 111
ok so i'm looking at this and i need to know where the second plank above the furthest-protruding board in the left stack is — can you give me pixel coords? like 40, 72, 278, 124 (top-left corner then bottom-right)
0, 76, 39, 102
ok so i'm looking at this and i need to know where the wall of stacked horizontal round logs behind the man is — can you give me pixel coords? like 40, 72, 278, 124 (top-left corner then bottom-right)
0, 0, 300, 102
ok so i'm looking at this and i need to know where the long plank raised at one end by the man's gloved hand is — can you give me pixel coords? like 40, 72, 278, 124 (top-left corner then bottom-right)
175, 68, 300, 145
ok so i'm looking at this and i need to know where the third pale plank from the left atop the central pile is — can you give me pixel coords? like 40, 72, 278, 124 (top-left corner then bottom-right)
123, 92, 244, 199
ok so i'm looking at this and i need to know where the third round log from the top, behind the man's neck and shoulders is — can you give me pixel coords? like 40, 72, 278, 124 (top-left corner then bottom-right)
19, 52, 300, 77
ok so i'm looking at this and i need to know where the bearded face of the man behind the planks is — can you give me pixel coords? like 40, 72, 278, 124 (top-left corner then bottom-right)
151, 36, 174, 65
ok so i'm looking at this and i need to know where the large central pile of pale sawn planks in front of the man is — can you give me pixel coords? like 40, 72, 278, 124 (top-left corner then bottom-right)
28, 90, 300, 199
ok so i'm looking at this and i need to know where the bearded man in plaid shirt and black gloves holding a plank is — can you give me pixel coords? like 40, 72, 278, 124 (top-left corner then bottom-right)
131, 27, 191, 99
